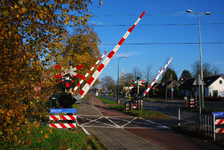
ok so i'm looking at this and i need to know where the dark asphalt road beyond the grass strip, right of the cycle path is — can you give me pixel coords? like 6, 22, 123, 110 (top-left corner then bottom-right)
101, 94, 224, 117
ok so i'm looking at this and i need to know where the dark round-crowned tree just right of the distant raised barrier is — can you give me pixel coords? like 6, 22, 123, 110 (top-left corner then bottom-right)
161, 68, 177, 100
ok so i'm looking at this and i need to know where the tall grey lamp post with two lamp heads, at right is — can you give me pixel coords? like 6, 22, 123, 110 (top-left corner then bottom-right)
186, 10, 211, 108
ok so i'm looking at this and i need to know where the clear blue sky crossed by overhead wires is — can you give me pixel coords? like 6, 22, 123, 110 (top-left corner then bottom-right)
67, 0, 224, 84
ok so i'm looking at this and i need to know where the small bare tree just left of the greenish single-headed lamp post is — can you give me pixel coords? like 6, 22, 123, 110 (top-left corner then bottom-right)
101, 76, 116, 92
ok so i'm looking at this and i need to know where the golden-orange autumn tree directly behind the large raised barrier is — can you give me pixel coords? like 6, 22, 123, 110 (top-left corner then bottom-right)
55, 25, 101, 93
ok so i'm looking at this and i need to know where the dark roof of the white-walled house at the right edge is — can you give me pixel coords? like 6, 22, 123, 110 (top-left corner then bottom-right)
179, 76, 221, 90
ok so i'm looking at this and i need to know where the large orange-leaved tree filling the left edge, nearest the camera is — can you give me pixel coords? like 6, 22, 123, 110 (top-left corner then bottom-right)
0, 0, 101, 148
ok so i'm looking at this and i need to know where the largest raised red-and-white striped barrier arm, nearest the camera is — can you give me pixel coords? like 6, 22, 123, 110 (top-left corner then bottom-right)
75, 11, 145, 101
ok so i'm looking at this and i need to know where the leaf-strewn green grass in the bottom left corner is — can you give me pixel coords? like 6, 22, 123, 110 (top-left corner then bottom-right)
0, 122, 108, 150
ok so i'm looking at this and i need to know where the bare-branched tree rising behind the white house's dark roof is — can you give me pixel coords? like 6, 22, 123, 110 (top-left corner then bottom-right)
191, 60, 221, 78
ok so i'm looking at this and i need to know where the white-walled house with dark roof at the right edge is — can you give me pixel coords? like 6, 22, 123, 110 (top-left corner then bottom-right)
179, 76, 224, 97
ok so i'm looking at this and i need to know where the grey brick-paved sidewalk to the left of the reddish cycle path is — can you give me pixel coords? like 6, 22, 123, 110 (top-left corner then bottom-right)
77, 96, 162, 150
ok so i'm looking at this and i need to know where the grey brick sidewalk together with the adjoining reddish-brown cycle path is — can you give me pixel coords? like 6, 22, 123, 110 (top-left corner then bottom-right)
77, 95, 223, 150
